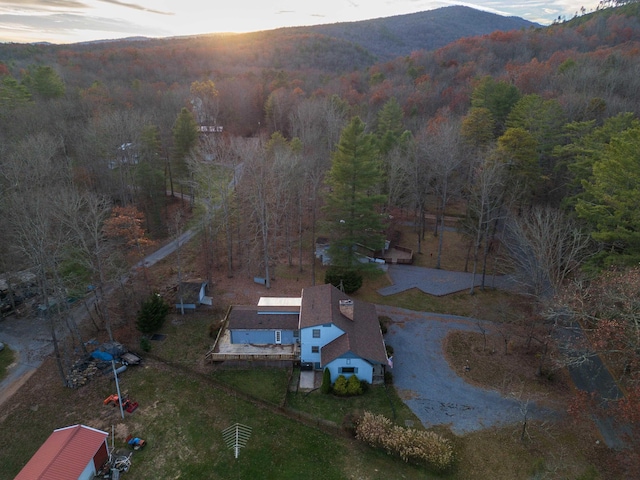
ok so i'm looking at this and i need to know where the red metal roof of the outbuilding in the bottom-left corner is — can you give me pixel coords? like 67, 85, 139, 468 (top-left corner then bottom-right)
15, 425, 109, 480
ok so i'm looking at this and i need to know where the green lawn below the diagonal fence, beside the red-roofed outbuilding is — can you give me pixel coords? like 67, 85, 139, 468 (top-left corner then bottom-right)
0, 348, 448, 480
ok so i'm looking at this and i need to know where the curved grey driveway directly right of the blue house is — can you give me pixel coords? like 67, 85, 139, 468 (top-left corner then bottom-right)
376, 305, 557, 434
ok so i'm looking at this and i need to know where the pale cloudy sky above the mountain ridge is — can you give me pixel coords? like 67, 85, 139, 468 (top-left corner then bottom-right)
0, 0, 598, 43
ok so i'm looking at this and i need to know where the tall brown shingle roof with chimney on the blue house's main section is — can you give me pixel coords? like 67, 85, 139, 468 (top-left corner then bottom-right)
300, 284, 387, 365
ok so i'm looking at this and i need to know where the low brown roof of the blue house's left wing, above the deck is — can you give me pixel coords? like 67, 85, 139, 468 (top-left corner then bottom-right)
228, 305, 300, 330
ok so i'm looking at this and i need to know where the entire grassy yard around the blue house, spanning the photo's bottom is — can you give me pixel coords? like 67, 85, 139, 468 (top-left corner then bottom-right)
0, 308, 600, 480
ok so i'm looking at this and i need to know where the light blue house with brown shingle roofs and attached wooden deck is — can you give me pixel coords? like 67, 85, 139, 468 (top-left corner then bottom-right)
207, 284, 388, 383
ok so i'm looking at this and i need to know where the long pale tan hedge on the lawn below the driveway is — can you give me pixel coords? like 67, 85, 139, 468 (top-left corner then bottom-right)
356, 412, 454, 472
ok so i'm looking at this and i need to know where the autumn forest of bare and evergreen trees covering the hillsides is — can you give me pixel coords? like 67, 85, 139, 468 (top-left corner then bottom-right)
0, 3, 640, 474
